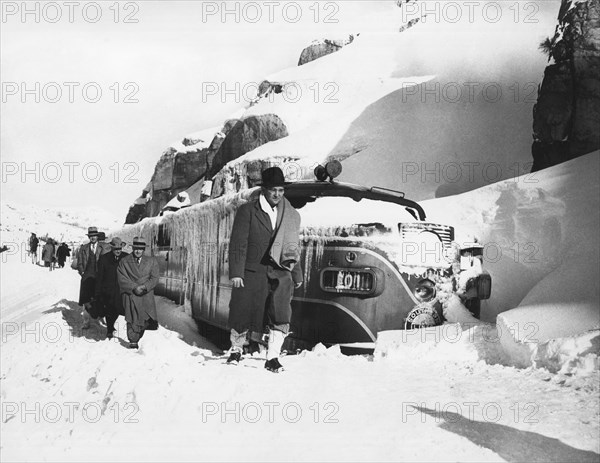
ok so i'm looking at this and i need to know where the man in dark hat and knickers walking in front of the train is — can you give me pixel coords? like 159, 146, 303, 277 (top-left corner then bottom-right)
227, 167, 302, 373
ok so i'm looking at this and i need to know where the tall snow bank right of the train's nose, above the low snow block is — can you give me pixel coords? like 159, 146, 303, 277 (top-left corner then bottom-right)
422, 151, 600, 327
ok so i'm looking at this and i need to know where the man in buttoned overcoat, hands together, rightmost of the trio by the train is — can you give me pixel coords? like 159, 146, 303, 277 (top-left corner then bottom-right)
117, 236, 158, 349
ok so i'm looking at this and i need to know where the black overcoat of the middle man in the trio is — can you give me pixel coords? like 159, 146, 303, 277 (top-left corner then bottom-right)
94, 252, 129, 319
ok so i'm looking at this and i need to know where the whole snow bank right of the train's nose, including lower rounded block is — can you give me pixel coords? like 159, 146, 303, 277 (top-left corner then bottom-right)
423, 152, 600, 373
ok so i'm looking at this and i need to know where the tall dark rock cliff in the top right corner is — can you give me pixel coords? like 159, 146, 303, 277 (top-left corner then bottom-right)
532, 0, 600, 171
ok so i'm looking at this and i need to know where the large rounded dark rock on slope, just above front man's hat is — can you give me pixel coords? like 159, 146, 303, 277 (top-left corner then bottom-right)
208, 114, 288, 177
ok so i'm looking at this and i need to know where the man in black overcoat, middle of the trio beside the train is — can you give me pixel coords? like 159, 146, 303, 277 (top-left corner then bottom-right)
94, 237, 129, 339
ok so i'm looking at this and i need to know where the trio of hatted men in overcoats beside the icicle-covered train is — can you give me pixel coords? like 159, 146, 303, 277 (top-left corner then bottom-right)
76, 227, 158, 349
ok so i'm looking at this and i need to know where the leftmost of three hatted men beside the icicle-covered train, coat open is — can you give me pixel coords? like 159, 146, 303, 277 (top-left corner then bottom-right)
77, 227, 107, 329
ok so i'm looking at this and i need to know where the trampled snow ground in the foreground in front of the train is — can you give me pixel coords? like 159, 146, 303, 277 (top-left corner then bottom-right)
0, 257, 600, 461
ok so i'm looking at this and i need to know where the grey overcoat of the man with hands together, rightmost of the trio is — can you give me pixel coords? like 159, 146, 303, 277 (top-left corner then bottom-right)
117, 254, 159, 329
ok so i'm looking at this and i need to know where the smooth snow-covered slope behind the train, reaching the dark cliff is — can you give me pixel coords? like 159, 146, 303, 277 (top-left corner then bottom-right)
210, 1, 560, 200
